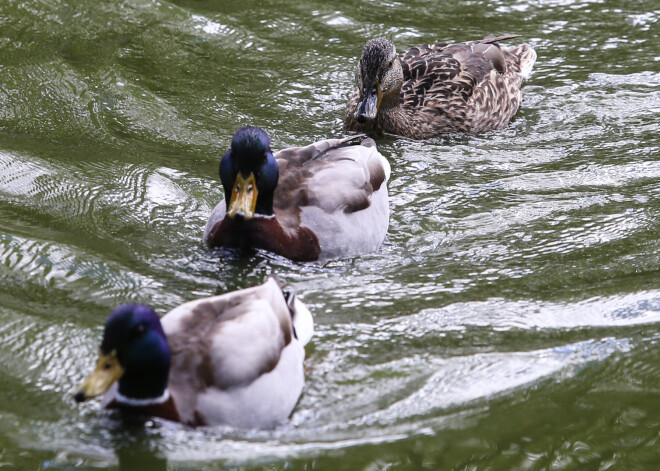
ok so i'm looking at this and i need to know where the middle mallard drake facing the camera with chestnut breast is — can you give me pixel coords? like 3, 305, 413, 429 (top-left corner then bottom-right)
204, 127, 390, 261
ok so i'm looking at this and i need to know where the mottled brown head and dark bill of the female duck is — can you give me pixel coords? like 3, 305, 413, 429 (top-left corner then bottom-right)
355, 38, 403, 123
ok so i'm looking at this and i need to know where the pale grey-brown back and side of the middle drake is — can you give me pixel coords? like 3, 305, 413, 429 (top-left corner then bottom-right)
274, 136, 390, 257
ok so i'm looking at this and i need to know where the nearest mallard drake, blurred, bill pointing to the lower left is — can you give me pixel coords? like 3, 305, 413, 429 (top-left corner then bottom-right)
75, 277, 313, 428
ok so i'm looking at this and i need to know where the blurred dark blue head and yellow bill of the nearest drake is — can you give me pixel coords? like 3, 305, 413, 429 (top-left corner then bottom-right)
75, 304, 170, 402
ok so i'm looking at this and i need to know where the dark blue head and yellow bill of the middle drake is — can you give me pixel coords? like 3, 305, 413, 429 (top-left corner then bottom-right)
220, 126, 279, 220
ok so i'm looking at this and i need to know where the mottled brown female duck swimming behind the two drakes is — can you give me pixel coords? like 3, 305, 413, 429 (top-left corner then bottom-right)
345, 35, 536, 139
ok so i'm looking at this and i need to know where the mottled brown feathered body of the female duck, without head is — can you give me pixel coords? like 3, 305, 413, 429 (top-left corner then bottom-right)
400, 36, 536, 137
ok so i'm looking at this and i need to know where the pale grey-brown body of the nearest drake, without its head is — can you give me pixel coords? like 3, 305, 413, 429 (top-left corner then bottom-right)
161, 278, 311, 428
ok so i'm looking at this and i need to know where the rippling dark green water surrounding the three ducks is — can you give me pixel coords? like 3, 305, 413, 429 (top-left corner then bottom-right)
0, 0, 660, 470
